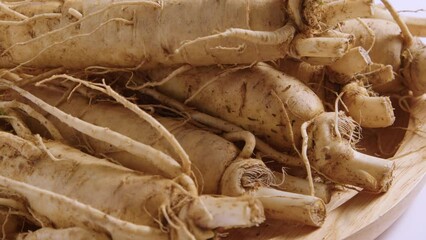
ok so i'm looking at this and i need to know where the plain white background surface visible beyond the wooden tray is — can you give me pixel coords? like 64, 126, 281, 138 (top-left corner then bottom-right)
376, 0, 426, 240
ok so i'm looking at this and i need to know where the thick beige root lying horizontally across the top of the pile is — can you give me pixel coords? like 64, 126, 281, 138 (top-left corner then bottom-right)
0, 0, 292, 69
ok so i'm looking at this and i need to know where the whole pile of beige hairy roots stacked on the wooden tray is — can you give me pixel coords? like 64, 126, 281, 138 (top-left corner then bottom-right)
0, 0, 426, 239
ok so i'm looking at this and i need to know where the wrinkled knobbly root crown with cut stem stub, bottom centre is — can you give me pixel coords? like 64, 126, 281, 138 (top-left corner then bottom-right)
221, 159, 325, 227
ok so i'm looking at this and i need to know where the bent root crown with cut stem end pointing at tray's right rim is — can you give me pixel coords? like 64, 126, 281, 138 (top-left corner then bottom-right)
308, 113, 394, 193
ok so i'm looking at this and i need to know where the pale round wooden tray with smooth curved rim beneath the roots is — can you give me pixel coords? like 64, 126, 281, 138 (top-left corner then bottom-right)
230, 95, 426, 240
